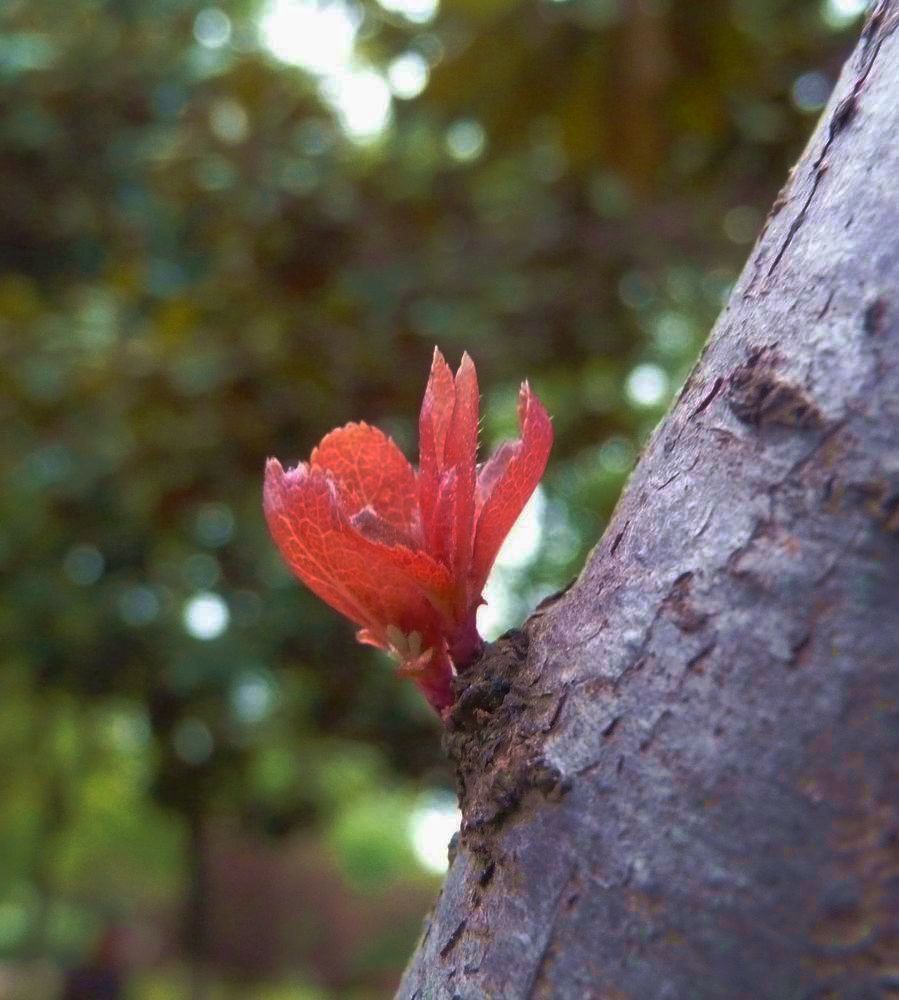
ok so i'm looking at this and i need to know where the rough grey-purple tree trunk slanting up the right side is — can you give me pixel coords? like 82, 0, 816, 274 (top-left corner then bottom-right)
399, 0, 899, 1000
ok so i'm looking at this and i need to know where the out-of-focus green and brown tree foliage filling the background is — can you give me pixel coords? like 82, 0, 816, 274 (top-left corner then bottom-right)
0, 0, 860, 996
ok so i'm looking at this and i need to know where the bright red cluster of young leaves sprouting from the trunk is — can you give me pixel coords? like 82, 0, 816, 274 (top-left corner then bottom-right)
264, 349, 552, 711
